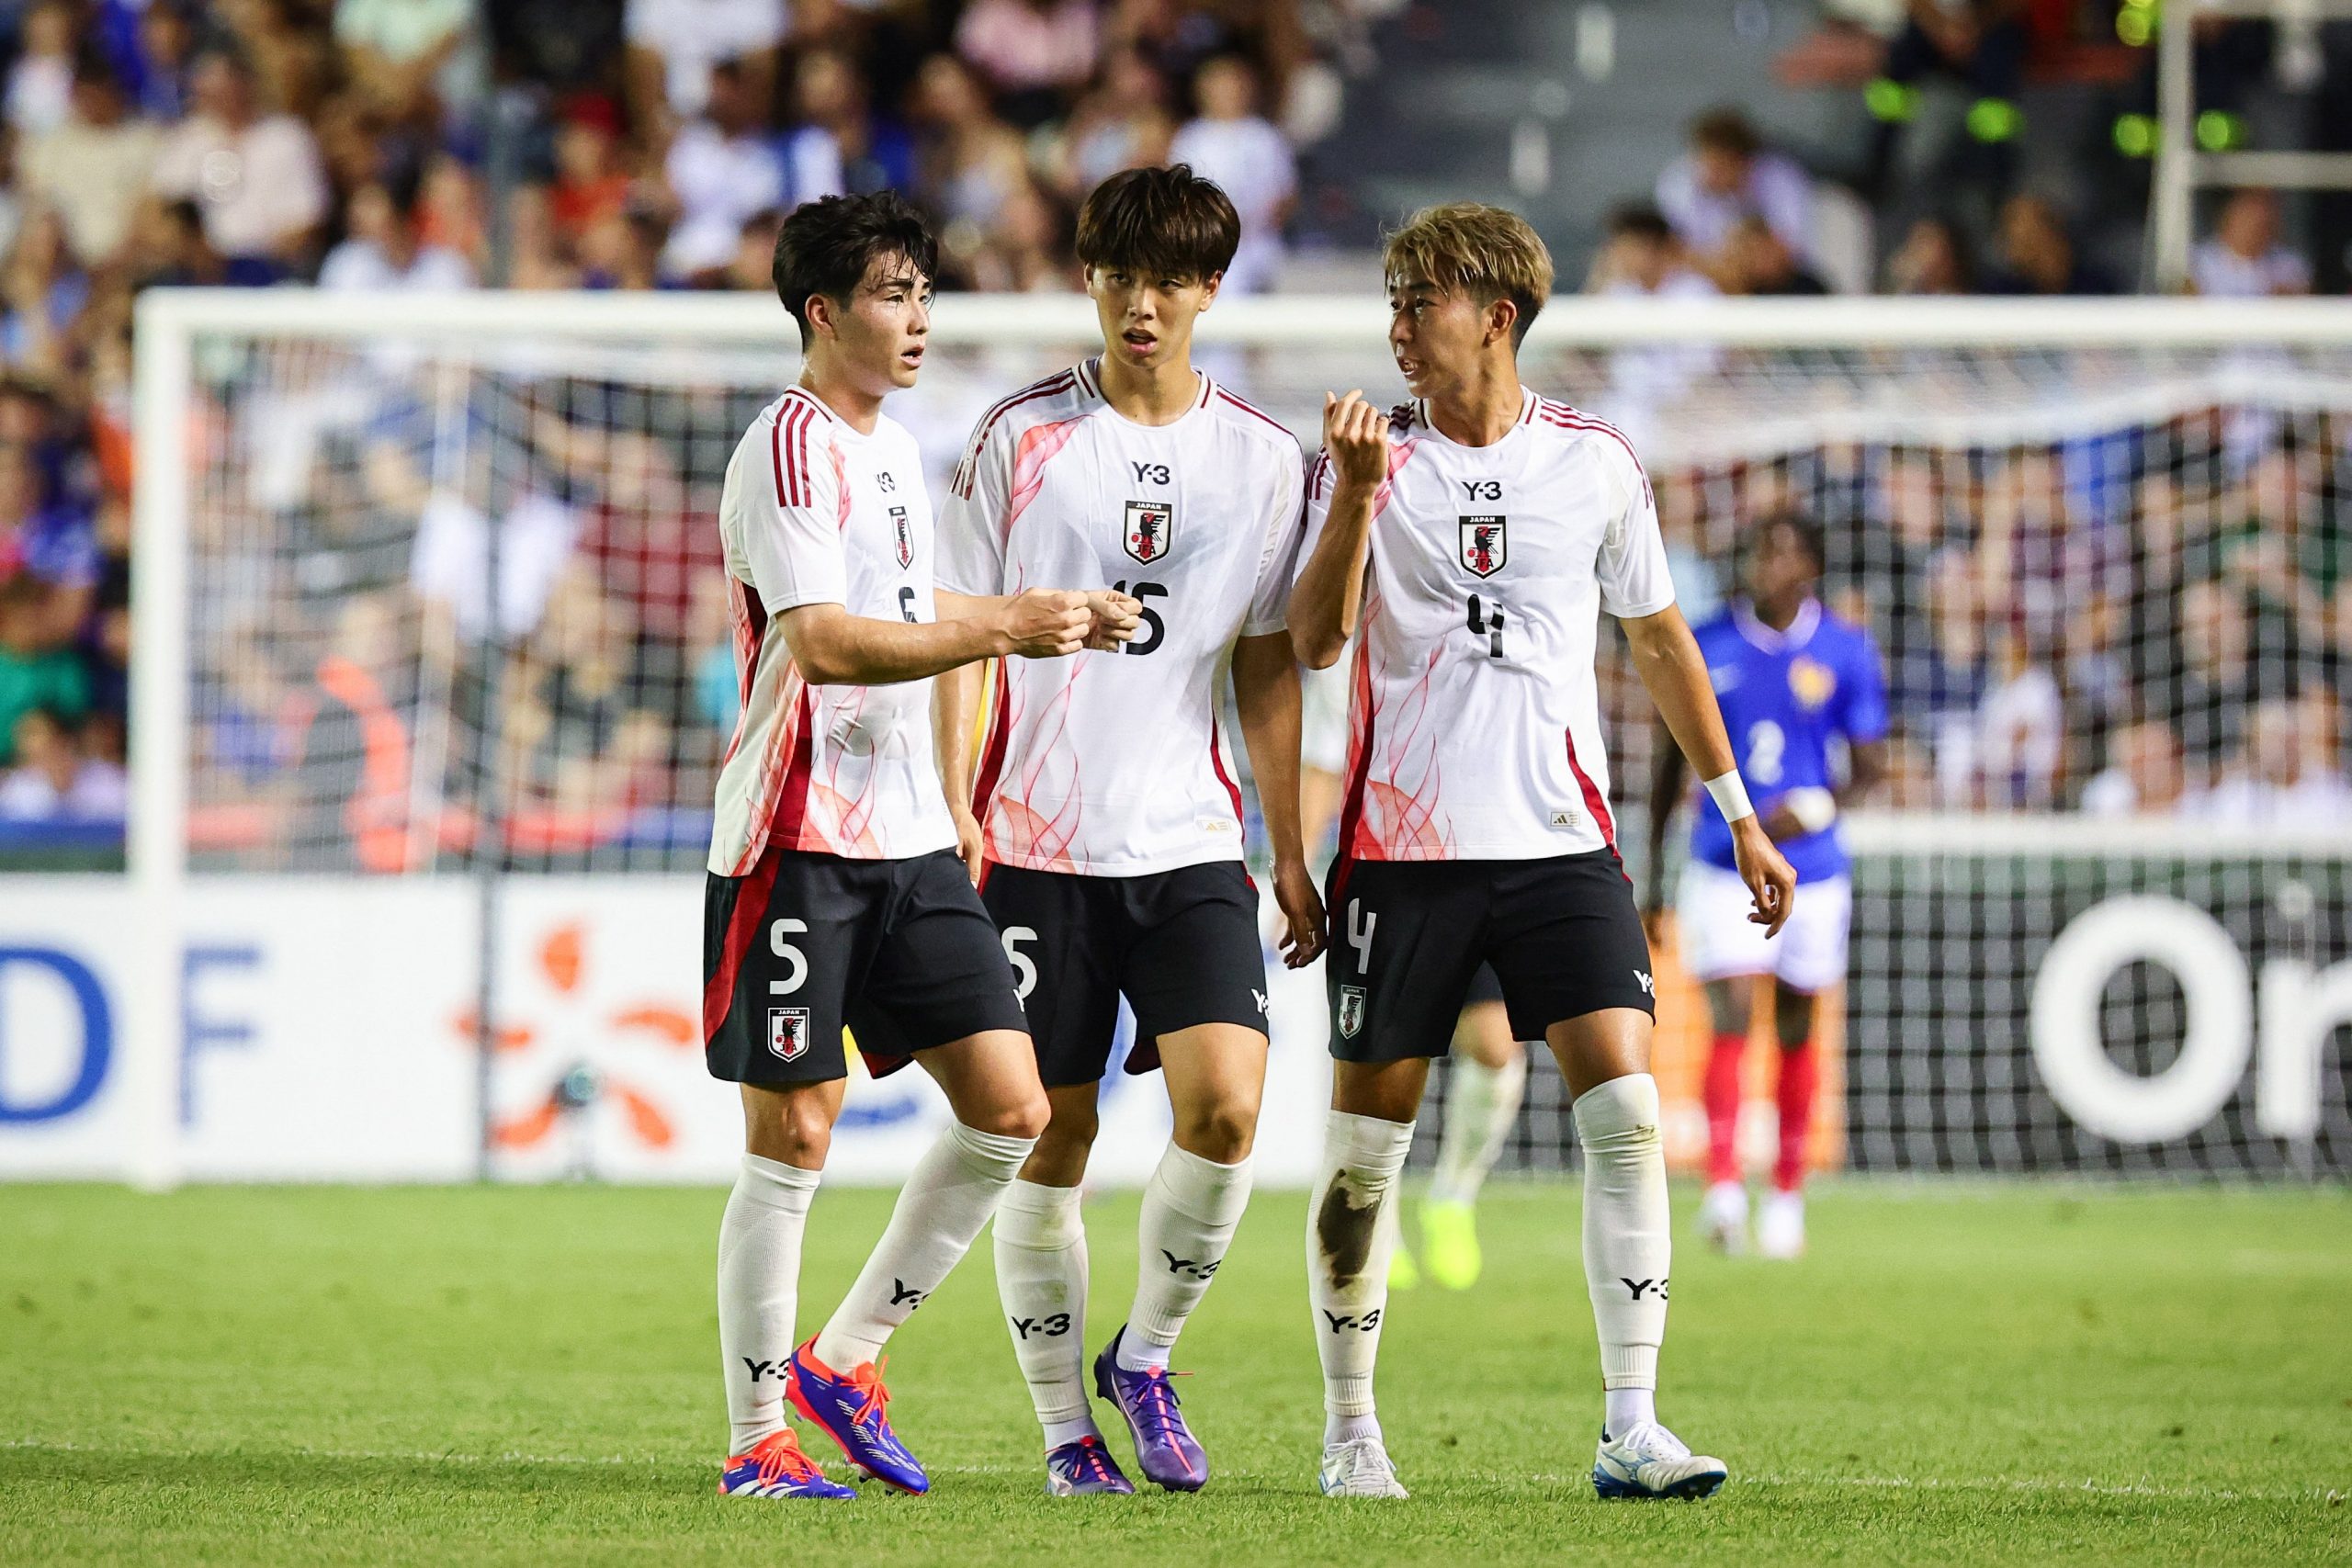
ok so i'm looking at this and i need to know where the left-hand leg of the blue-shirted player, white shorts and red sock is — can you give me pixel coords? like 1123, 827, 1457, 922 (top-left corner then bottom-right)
1675, 861, 1773, 1253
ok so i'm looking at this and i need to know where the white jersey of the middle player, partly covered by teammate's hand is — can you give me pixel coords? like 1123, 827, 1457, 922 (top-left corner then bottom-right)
938, 360, 1303, 877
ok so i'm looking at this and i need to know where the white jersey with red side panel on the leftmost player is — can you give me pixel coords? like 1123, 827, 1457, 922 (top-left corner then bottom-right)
710, 388, 955, 877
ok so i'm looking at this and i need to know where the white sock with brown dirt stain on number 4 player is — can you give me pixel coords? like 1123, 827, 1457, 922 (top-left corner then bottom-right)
1307, 1110, 1414, 1443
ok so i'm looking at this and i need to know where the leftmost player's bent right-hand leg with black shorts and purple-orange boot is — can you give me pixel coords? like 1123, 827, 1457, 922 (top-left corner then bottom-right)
793, 851, 1046, 1491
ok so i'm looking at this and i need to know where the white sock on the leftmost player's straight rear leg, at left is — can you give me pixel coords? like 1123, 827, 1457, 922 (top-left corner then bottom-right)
719, 1155, 819, 1455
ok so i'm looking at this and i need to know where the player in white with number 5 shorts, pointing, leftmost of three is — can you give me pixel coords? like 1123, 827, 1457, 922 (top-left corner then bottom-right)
703, 195, 1134, 1497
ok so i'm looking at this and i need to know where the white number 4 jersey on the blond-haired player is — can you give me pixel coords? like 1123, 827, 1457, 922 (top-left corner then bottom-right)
1301, 392, 1675, 861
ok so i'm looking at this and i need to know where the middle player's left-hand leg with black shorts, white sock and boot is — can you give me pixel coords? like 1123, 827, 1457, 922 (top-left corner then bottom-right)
981, 865, 1134, 1497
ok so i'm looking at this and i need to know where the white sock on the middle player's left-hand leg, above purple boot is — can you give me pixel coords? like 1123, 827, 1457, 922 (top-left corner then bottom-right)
995, 1180, 1101, 1450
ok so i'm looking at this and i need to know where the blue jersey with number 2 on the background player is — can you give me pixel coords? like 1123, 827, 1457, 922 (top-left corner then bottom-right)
1691, 600, 1886, 882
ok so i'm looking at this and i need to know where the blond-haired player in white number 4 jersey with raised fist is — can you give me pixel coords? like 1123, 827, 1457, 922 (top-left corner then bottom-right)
1291, 202, 1794, 1497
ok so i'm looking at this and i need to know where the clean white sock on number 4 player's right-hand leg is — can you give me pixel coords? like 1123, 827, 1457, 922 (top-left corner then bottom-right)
1571, 1072, 1675, 1434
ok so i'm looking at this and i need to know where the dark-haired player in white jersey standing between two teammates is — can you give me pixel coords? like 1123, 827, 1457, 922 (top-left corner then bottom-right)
941, 164, 1322, 1495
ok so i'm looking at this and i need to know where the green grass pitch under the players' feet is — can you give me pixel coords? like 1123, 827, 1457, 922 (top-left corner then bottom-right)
0, 1185, 2352, 1568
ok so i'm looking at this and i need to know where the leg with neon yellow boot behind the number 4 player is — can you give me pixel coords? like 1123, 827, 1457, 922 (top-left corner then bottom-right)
1420, 966, 1526, 1291
